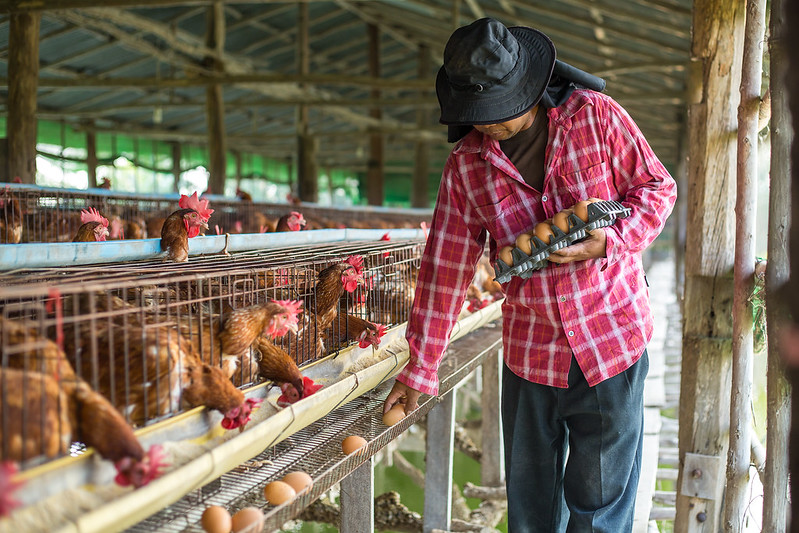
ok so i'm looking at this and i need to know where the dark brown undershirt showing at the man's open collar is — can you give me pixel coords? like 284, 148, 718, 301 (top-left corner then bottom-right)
499, 107, 547, 191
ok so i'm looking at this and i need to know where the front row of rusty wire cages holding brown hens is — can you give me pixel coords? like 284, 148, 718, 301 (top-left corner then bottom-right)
0, 239, 424, 469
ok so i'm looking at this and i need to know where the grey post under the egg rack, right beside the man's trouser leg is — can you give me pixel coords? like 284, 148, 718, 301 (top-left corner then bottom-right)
480, 349, 505, 487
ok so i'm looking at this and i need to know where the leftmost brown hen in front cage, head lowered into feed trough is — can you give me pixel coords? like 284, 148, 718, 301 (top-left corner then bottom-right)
0, 319, 163, 487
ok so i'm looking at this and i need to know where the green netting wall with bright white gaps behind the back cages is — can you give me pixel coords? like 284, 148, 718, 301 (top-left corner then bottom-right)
0, 117, 440, 207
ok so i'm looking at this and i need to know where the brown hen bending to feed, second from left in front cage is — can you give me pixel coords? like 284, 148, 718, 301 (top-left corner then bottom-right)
64, 297, 259, 429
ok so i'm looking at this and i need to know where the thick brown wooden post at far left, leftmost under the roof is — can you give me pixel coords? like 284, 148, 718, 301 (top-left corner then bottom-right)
6, 12, 42, 183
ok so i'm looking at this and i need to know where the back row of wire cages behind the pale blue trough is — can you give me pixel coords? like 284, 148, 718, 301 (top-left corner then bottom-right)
0, 183, 432, 244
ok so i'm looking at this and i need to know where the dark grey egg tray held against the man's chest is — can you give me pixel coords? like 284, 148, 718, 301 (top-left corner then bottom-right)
494, 200, 630, 283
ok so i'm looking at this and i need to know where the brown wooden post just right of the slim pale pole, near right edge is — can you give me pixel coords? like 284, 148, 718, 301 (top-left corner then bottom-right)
763, 0, 793, 531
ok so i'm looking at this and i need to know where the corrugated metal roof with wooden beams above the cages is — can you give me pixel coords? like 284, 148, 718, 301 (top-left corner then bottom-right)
0, 0, 692, 172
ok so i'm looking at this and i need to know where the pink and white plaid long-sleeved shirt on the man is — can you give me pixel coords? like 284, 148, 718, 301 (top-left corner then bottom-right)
397, 90, 676, 394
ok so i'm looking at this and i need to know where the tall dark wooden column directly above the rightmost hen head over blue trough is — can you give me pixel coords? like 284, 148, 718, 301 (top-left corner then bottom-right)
297, 2, 319, 202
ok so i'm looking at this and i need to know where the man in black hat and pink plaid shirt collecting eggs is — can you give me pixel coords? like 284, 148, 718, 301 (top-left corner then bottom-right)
384, 19, 676, 533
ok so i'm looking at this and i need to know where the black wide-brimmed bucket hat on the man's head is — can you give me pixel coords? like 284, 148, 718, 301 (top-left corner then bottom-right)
436, 18, 555, 126
